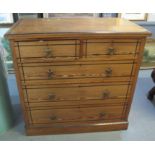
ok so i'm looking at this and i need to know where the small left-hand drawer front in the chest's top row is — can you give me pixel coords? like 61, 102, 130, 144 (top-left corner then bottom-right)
16, 41, 79, 59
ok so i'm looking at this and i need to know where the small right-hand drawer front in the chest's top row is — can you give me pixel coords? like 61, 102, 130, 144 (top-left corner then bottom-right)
85, 40, 137, 59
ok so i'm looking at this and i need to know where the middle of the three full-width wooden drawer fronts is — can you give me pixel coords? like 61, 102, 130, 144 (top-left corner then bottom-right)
25, 84, 128, 102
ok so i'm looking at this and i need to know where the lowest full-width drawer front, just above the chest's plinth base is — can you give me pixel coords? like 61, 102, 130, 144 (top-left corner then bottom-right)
30, 106, 123, 124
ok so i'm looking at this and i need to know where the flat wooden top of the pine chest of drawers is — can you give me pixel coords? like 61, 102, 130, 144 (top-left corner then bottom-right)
6, 18, 151, 39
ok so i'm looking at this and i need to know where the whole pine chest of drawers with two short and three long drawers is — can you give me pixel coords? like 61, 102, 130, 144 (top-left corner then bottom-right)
6, 18, 150, 135
